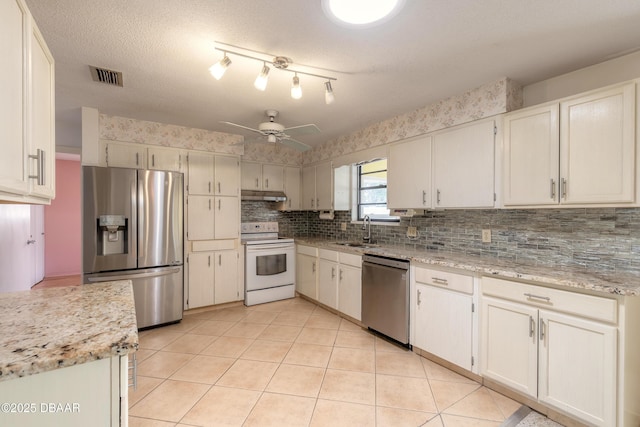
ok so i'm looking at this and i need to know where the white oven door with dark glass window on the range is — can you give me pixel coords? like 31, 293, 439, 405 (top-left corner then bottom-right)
245, 243, 296, 291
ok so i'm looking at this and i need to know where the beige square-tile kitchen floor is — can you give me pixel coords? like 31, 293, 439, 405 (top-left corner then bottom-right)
129, 298, 520, 427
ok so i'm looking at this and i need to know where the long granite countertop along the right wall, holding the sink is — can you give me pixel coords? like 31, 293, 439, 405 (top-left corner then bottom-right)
295, 237, 640, 296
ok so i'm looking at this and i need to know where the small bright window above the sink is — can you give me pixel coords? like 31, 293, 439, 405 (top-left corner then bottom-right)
357, 159, 399, 222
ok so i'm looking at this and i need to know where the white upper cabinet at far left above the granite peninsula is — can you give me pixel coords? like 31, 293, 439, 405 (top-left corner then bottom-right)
0, 0, 55, 203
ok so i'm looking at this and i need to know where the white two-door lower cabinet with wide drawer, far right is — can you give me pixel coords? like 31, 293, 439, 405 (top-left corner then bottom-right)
481, 278, 618, 426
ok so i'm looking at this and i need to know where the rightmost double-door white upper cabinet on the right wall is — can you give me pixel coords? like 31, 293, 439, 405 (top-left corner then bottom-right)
503, 83, 637, 206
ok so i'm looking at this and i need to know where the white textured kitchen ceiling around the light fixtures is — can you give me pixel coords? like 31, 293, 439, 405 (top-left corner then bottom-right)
26, 0, 640, 150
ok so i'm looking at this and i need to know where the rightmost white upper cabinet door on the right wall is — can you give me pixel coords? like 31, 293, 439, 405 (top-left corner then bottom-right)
560, 83, 636, 204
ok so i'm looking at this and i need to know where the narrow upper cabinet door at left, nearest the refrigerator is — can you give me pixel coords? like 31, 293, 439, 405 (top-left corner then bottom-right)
29, 24, 56, 199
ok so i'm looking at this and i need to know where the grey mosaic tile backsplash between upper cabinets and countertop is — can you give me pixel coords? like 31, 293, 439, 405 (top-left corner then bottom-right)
242, 201, 640, 273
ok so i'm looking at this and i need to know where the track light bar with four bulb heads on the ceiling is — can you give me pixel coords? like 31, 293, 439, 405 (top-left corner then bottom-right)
209, 42, 337, 104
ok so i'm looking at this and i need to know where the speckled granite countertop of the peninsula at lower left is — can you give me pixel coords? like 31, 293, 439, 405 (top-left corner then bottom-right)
0, 280, 138, 381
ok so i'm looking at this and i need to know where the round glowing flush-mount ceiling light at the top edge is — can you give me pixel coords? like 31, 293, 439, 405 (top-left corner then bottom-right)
322, 0, 405, 27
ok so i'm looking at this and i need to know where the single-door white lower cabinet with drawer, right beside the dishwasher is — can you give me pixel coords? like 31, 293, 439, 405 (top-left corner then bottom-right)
412, 267, 477, 372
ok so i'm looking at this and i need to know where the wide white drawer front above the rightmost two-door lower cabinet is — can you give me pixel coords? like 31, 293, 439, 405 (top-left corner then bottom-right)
482, 277, 618, 323
